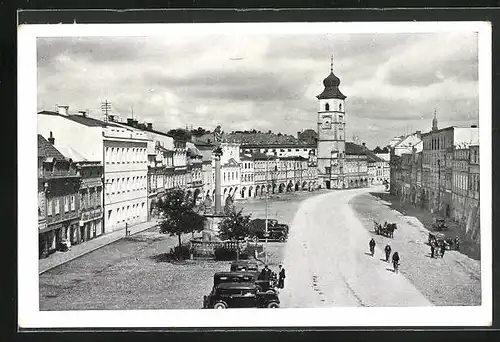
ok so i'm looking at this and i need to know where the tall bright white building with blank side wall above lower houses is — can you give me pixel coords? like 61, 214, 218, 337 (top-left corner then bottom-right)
38, 106, 148, 232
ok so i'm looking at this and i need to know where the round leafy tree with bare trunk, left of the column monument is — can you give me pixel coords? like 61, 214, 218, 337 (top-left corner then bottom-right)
157, 188, 205, 259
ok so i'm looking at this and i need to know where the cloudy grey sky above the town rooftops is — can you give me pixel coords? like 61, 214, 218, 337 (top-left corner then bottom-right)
37, 32, 478, 148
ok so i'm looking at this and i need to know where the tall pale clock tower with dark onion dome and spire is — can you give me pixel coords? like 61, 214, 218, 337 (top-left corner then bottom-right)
316, 57, 346, 188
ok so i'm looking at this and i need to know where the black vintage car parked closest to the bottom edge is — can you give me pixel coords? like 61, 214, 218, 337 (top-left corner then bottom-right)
203, 282, 280, 309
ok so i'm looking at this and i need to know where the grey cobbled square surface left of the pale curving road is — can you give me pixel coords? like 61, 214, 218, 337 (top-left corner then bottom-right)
40, 192, 306, 310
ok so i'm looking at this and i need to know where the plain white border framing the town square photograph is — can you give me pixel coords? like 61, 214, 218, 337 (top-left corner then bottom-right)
18, 22, 492, 328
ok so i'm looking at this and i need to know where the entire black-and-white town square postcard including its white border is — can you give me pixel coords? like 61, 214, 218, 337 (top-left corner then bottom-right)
19, 22, 491, 327
